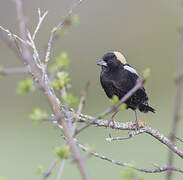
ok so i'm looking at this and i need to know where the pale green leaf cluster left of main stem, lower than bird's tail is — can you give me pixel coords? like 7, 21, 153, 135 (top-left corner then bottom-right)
29, 108, 48, 125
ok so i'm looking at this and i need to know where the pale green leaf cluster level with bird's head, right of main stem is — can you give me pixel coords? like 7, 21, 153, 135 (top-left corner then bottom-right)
49, 51, 70, 72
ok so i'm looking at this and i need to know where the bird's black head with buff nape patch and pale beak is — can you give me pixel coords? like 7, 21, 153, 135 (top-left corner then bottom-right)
97, 51, 126, 69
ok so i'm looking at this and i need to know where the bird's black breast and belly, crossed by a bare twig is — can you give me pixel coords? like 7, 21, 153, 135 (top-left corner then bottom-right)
100, 68, 148, 109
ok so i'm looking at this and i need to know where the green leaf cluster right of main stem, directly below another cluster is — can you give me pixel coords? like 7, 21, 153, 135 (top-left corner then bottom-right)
51, 71, 70, 90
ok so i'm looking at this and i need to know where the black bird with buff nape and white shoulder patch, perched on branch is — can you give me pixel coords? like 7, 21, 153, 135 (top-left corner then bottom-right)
97, 52, 155, 130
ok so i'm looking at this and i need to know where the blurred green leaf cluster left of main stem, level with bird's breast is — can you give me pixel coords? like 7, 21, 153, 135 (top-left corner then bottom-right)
17, 79, 35, 94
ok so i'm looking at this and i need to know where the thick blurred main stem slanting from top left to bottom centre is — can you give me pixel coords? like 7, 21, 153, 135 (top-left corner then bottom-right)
12, 0, 89, 180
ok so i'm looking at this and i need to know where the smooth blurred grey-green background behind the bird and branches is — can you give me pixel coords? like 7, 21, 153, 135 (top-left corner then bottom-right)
0, 0, 183, 180
